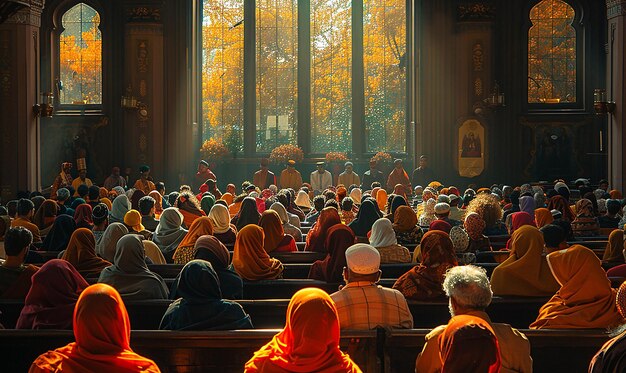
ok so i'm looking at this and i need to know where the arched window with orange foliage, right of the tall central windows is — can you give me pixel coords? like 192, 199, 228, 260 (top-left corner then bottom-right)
528, 0, 578, 105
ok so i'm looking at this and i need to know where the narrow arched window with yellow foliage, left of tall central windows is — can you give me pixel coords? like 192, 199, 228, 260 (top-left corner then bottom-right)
59, 3, 102, 105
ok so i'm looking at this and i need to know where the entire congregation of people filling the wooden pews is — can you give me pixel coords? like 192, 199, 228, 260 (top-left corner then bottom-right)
0, 156, 626, 373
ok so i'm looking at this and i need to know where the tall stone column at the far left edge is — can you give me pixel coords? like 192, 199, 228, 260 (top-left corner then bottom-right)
0, 0, 44, 199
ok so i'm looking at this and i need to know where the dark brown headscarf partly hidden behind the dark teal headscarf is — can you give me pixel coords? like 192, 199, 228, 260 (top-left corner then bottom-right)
195, 235, 243, 299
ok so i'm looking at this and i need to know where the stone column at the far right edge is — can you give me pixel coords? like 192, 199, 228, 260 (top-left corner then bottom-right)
606, 0, 626, 191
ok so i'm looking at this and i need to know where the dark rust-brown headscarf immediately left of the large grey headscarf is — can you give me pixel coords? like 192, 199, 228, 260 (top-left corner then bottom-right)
62, 228, 111, 277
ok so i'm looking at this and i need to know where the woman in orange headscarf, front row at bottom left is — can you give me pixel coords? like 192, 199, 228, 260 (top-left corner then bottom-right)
29, 284, 160, 373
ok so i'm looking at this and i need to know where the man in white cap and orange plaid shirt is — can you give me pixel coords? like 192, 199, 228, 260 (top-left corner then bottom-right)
330, 244, 413, 329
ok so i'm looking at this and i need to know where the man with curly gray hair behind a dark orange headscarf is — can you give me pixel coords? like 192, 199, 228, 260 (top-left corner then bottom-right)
415, 265, 533, 373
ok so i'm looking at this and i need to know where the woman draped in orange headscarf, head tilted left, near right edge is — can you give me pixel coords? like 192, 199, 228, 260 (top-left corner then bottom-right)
530, 245, 624, 329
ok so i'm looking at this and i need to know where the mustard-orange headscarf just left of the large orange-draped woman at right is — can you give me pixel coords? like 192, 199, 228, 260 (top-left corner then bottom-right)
491, 225, 559, 297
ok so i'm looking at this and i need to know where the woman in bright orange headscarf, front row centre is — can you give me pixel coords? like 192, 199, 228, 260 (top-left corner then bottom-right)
244, 288, 361, 373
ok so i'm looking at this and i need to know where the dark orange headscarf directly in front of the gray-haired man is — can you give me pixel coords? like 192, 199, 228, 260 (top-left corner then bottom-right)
439, 315, 502, 373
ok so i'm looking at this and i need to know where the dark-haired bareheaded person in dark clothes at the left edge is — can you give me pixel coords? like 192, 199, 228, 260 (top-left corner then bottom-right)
0, 227, 39, 299
